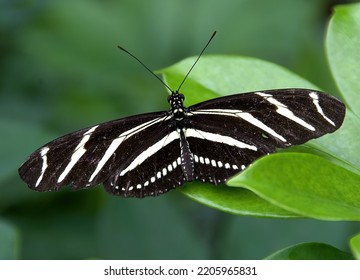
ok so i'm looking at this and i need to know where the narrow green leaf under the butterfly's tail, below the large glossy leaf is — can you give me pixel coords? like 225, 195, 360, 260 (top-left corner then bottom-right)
181, 183, 299, 218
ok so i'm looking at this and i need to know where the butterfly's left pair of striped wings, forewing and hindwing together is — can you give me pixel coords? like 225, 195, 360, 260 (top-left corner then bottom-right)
19, 112, 184, 197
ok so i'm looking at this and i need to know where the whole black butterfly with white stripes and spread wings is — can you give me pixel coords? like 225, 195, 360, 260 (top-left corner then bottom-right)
19, 33, 345, 198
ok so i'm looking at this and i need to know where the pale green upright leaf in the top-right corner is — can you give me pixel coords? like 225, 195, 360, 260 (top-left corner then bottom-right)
326, 4, 360, 116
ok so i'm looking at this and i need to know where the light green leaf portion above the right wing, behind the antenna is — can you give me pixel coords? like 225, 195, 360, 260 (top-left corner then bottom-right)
159, 55, 317, 102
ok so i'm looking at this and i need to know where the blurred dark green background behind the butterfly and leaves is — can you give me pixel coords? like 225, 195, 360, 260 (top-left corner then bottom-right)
0, 0, 360, 259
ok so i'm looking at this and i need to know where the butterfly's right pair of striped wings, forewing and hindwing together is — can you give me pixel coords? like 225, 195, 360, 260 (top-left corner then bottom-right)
186, 89, 345, 184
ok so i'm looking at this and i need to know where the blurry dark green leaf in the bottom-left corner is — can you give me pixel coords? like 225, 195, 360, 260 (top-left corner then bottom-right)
0, 220, 19, 260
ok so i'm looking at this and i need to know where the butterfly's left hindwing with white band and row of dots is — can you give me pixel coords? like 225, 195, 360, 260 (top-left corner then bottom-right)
104, 131, 185, 198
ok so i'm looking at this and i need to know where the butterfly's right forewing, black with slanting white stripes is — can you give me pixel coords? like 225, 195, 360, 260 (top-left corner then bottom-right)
189, 89, 345, 148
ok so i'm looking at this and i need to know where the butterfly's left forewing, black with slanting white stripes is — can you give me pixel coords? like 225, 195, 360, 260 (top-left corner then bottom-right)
19, 112, 172, 191
